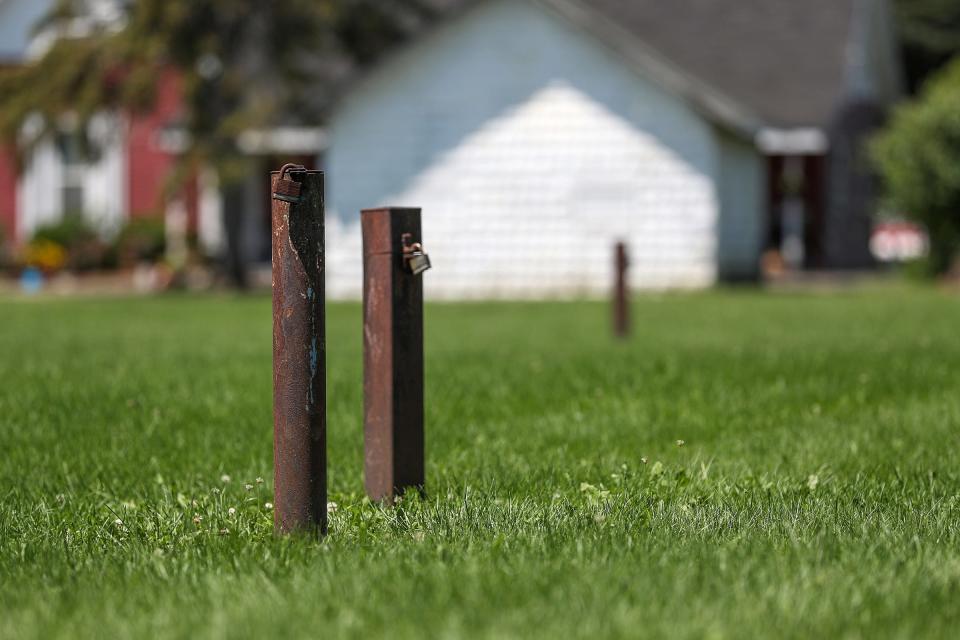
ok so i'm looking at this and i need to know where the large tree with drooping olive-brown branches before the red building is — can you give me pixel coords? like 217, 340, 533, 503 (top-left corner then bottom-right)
0, 0, 437, 285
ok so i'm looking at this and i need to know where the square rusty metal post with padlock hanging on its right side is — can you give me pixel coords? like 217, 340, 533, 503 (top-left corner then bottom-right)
360, 208, 430, 502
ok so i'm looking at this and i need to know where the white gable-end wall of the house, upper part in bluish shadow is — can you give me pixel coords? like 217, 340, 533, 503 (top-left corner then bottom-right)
326, 0, 756, 298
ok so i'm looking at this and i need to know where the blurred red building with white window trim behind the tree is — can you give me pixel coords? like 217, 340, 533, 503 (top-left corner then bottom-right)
0, 0, 322, 263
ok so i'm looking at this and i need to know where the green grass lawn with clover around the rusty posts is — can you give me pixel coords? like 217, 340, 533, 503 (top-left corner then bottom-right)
0, 289, 960, 638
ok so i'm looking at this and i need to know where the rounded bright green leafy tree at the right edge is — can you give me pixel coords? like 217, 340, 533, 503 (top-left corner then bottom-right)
871, 59, 960, 274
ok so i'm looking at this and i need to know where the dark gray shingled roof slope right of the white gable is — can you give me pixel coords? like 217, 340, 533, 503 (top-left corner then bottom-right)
579, 0, 856, 127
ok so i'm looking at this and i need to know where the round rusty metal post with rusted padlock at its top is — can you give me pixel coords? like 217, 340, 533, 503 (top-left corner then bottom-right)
270, 165, 327, 534
